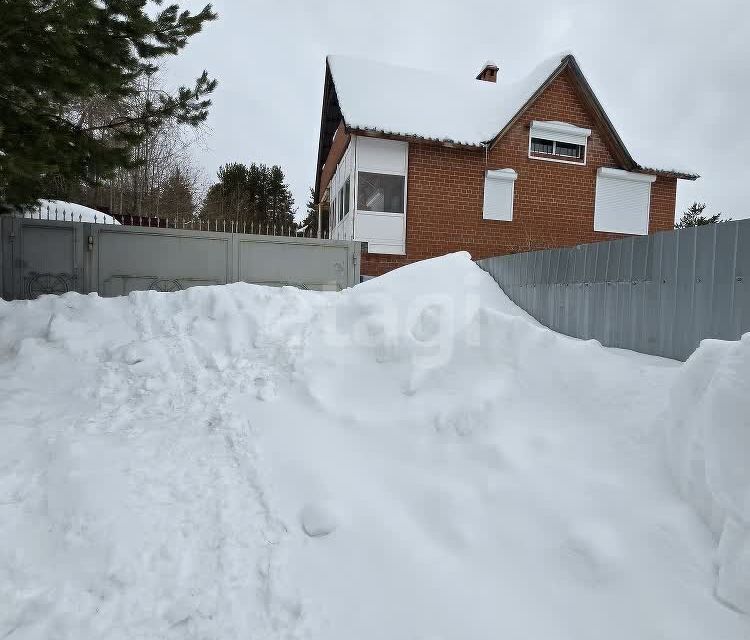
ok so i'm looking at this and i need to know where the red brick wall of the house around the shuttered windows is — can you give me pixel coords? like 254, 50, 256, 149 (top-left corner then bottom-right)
362, 72, 677, 275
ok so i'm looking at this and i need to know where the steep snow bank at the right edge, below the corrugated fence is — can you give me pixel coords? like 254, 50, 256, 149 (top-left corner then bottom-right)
666, 334, 750, 613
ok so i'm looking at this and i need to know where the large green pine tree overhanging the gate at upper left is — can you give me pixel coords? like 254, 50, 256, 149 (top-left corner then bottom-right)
0, 0, 216, 206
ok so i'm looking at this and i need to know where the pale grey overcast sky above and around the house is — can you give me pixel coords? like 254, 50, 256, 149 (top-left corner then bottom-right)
167, 0, 750, 218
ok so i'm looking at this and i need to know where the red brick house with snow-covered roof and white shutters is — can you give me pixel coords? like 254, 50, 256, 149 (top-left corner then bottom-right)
315, 55, 698, 276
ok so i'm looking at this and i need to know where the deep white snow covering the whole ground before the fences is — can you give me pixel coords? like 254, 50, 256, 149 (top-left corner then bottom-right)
0, 254, 750, 640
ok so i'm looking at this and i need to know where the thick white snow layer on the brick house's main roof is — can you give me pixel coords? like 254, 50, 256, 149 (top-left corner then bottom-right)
328, 55, 565, 146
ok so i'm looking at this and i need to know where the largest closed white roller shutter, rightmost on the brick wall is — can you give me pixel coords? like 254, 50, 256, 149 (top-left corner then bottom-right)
594, 167, 656, 235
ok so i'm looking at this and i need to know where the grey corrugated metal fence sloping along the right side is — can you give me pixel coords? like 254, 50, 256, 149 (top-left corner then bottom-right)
478, 220, 750, 360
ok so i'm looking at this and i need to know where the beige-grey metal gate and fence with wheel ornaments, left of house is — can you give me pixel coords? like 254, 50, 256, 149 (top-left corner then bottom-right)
0, 216, 362, 300
